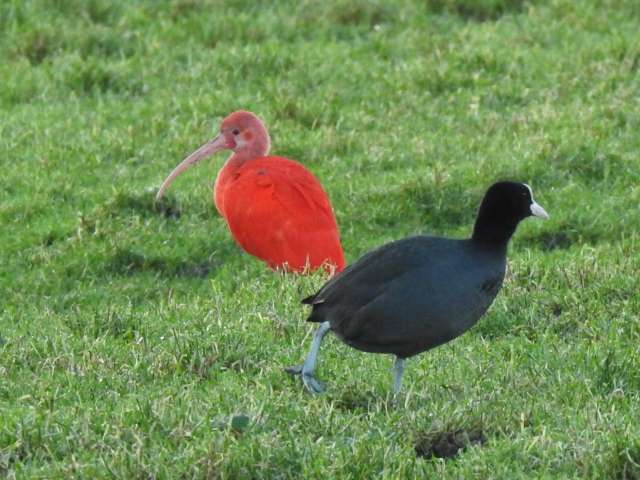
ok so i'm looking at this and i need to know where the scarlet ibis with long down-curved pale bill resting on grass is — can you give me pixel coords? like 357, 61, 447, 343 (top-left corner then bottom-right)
156, 110, 345, 273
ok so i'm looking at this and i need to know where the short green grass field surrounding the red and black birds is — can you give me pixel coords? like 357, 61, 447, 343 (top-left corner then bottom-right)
0, 0, 640, 479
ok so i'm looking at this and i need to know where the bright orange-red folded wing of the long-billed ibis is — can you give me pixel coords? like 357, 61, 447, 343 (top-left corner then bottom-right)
220, 157, 344, 271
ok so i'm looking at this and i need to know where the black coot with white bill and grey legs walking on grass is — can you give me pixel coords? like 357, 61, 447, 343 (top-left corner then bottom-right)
286, 182, 549, 393
